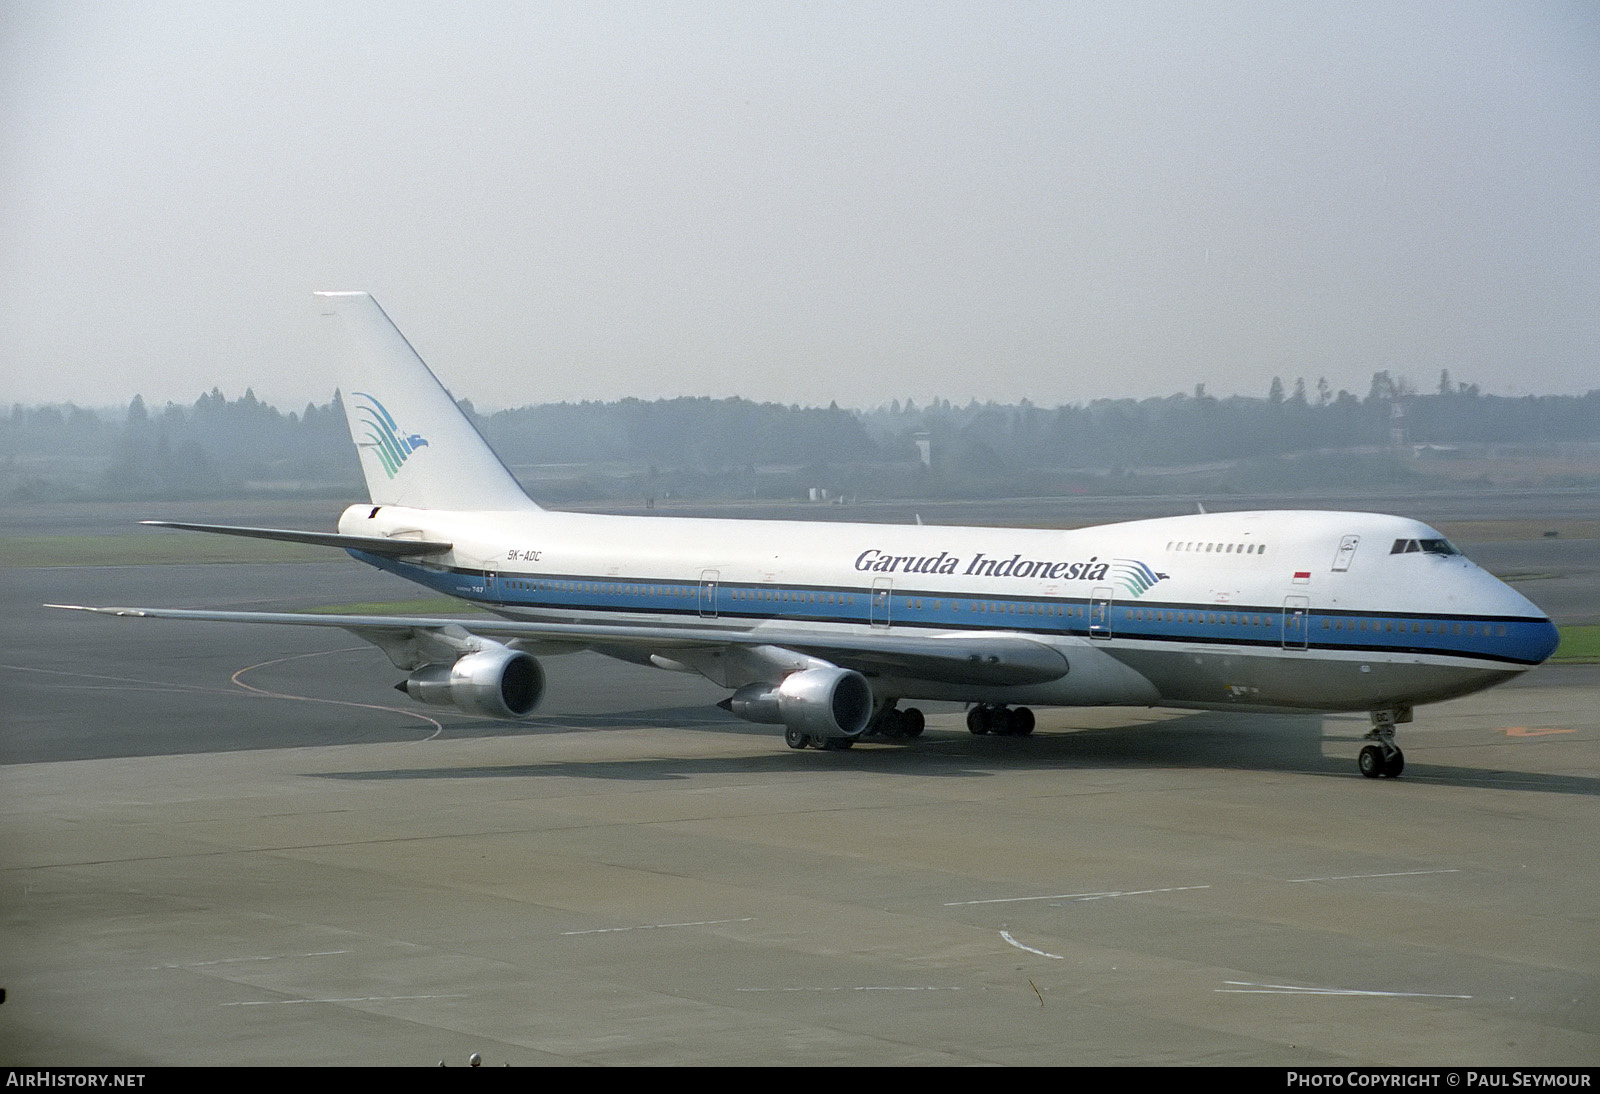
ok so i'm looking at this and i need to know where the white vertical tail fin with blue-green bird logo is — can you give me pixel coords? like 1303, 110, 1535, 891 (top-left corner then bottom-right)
317, 293, 538, 510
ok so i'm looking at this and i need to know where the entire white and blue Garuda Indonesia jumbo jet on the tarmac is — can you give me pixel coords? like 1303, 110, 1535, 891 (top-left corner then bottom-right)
53, 293, 1557, 777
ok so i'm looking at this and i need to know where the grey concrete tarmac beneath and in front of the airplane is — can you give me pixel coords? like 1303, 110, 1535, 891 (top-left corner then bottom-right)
0, 499, 1600, 1067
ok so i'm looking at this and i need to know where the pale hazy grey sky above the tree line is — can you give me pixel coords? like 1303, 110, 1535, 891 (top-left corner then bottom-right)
0, 0, 1600, 408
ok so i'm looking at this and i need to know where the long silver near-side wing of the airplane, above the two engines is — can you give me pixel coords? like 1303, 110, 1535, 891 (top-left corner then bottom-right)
46, 605, 1067, 686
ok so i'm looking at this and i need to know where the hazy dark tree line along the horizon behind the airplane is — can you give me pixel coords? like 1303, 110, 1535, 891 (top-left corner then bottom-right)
0, 373, 1600, 502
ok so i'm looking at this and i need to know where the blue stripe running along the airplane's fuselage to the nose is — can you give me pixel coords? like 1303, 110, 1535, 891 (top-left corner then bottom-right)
350, 550, 1555, 665
